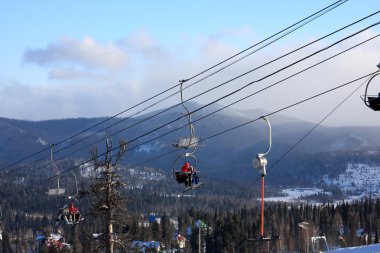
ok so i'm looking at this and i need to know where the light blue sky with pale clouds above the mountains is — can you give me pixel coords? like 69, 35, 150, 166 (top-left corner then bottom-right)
0, 0, 380, 126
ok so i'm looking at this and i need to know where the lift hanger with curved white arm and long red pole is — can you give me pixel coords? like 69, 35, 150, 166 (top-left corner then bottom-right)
253, 117, 279, 241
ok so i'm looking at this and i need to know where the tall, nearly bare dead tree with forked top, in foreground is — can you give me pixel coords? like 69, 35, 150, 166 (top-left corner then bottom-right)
90, 138, 127, 253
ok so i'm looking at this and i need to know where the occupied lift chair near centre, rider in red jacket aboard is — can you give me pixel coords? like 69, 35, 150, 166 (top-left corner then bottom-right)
172, 153, 202, 192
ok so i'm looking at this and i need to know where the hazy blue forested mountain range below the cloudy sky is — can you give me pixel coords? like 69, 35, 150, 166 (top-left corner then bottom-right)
0, 103, 380, 190
